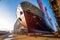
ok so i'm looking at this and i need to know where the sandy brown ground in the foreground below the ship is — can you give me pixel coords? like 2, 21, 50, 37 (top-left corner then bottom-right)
0, 34, 60, 40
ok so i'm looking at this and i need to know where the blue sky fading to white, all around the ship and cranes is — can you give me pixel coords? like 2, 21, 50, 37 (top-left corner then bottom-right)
0, 0, 56, 31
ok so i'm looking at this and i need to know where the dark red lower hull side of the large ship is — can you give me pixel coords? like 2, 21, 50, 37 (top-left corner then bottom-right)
24, 11, 53, 33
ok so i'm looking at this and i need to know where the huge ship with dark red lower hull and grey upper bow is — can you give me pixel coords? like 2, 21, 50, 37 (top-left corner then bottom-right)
16, 1, 58, 35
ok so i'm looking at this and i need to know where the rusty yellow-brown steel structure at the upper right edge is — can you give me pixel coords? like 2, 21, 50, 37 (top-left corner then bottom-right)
49, 0, 60, 28
